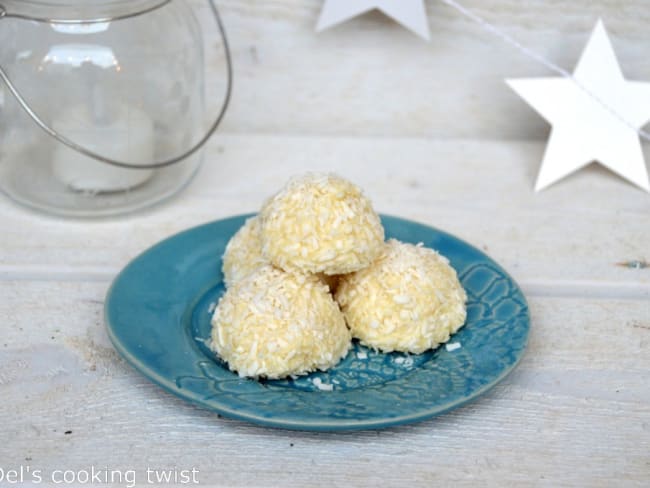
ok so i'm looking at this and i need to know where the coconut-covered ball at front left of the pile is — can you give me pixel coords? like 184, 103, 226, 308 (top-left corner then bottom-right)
211, 265, 351, 379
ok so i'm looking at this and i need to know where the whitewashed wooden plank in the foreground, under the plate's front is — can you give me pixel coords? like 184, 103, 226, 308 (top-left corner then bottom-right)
0, 281, 650, 487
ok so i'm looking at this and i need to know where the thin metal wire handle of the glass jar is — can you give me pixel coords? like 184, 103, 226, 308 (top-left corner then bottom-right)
0, 0, 233, 169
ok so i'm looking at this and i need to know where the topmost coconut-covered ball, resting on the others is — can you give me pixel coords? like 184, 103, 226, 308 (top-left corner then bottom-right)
261, 173, 384, 275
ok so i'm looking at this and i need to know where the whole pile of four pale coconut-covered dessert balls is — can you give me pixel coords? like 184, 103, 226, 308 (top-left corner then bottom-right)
211, 173, 466, 379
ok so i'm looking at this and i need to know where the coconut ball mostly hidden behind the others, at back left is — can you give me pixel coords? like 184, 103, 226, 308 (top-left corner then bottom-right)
222, 216, 269, 287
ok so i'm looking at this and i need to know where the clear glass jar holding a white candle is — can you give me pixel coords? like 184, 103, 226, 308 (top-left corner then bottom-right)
0, 0, 231, 216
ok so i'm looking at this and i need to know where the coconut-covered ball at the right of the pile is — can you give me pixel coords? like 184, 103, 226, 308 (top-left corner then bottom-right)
336, 239, 467, 354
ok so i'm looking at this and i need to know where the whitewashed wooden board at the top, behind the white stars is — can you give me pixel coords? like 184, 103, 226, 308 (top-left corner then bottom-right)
192, 0, 650, 139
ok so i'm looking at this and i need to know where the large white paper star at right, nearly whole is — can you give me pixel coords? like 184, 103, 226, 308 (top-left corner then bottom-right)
506, 20, 650, 191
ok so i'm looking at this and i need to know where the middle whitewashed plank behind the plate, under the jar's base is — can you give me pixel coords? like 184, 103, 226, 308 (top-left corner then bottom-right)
0, 133, 650, 298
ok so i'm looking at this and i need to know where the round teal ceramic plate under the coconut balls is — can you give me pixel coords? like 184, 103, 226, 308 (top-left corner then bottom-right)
105, 216, 529, 431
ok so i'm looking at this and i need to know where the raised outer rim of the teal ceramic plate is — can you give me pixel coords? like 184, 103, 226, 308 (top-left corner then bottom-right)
104, 213, 531, 432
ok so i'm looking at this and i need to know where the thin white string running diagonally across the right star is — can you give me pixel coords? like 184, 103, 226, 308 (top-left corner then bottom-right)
440, 0, 650, 142
